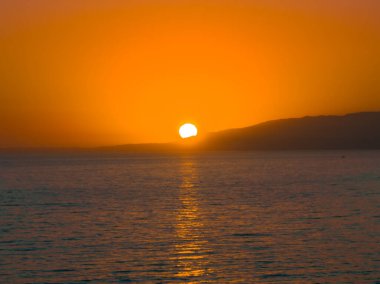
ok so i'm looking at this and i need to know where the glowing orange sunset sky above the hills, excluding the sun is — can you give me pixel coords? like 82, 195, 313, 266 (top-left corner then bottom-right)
0, 0, 380, 147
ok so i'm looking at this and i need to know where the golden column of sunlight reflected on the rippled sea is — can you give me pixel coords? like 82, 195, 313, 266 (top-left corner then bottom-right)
175, 159, 212, 283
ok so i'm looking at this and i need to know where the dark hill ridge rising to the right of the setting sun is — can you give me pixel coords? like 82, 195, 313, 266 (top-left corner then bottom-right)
198, 112, 380, 150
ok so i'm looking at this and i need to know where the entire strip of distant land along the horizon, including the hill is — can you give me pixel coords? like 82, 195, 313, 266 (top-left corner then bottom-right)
0, 112, 380, 154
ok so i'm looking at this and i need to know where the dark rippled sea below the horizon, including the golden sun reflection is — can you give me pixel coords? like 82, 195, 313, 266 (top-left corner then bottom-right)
0, 151, 380, 283
